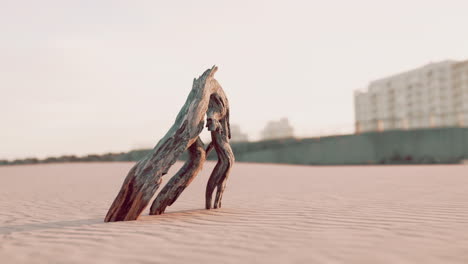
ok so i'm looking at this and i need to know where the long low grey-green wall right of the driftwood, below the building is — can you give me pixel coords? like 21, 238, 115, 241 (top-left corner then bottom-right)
229, 128, 468, 165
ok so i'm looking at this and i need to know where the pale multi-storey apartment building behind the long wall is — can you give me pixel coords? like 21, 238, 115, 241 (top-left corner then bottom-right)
354, 61, 468, 133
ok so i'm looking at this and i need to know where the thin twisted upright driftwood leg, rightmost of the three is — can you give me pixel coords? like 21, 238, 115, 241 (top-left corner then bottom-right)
205, 88, 234, 209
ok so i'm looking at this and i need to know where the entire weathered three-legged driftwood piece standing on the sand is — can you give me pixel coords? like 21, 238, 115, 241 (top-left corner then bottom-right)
104, 67, 234, 222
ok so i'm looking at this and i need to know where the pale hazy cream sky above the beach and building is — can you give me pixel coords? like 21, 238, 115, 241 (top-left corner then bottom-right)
0, 0, 468, 159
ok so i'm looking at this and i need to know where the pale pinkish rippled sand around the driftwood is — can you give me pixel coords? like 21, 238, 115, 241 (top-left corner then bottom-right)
0, 163, 468, 263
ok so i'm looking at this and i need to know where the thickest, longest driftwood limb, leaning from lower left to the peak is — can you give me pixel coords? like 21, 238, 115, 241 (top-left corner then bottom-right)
104, 67, 220, 222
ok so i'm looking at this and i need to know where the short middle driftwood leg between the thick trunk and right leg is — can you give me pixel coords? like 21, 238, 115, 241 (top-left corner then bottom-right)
150, 138, 206, 215
